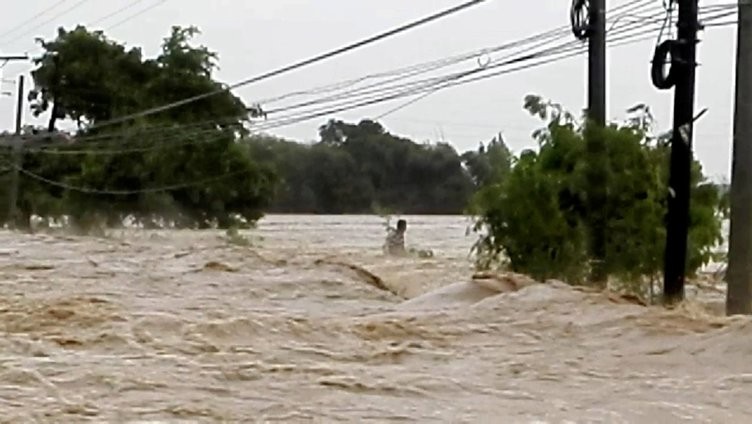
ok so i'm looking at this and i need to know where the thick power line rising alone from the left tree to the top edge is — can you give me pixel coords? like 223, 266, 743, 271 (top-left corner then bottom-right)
84, 0, 485, 127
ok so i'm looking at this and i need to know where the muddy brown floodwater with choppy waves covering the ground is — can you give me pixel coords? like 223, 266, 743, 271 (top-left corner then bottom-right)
0, 216, 752, 423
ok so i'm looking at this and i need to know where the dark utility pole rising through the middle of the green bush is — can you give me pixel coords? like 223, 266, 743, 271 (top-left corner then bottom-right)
585, 0, 608, 286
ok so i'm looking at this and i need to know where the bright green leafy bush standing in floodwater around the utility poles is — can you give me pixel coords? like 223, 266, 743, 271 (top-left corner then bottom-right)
473, 96, 725, 283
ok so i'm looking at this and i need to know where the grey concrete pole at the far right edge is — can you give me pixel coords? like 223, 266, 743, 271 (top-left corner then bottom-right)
726, 1, 752, 315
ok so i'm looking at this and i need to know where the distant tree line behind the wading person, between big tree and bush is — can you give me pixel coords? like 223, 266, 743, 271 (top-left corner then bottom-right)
252, 120, 474, 214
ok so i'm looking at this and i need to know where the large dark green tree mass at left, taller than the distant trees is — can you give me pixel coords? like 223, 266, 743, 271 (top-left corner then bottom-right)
2, 27, 276, 232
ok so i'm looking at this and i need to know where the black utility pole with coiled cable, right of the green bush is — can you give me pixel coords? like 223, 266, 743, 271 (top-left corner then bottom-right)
654, 0, 699, 304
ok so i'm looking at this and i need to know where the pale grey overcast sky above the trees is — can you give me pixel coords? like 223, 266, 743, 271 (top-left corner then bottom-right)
0, 0, 736, 177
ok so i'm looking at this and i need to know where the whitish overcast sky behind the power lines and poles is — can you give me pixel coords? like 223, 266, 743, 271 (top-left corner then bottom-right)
0, 0, 735, 175
